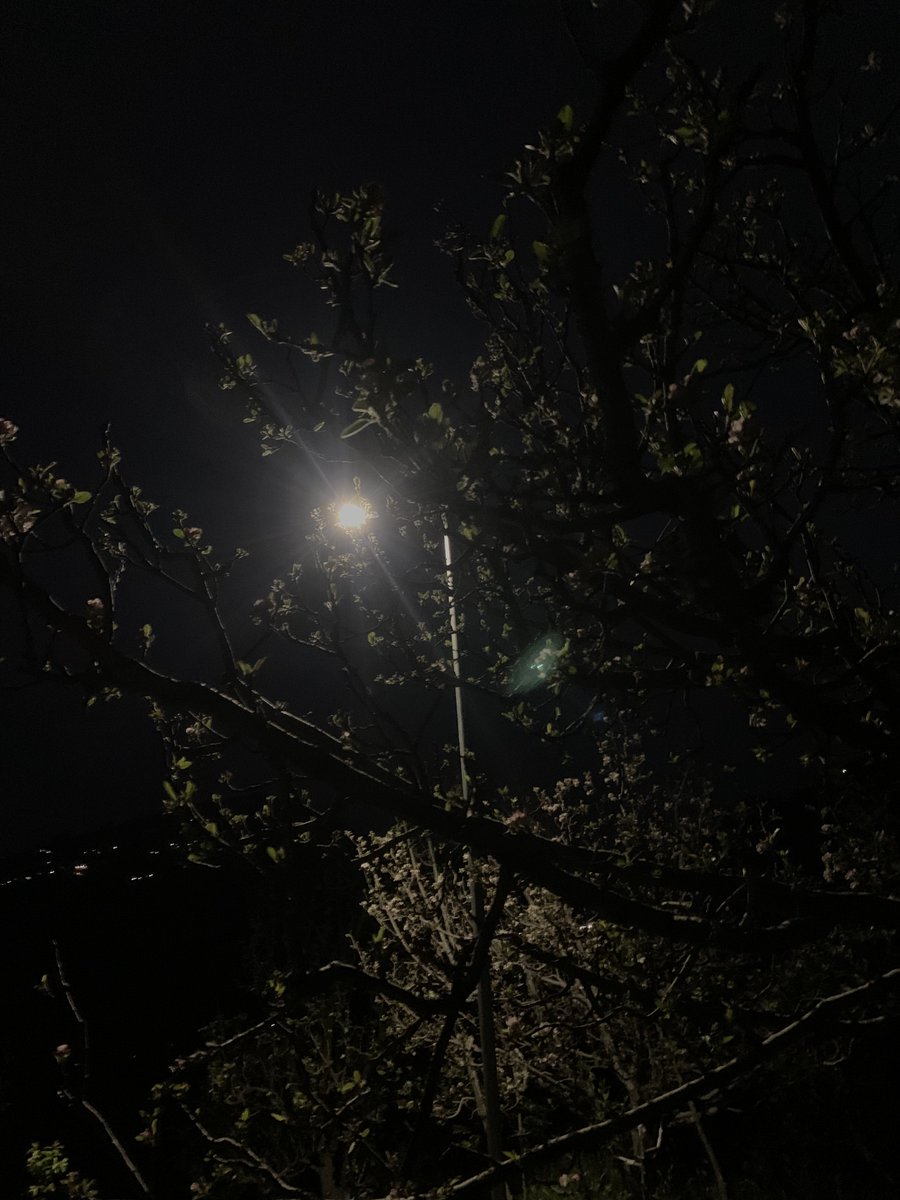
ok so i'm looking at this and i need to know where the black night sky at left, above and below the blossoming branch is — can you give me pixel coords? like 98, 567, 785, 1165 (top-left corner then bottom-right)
0, 0, 600, 856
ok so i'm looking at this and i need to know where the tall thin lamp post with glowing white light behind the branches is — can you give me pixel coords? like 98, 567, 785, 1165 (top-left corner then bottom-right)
336, 498, 505, 1171
